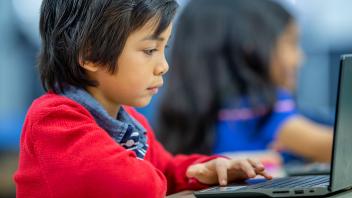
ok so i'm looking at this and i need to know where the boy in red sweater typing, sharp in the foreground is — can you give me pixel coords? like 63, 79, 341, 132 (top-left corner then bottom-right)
14, 0, 271, 198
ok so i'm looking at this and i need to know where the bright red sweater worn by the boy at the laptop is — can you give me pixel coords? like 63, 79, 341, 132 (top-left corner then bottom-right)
14, 93, 213, 198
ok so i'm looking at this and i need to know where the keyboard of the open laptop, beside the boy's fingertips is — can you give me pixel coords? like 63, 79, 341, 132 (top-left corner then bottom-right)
243, 175, 330, 189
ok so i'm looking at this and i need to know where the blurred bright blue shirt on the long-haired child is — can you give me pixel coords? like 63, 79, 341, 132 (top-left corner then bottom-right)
213, 89, 297, 161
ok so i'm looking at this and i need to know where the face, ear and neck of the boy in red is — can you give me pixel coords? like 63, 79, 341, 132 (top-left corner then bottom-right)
83, 20, 172, 116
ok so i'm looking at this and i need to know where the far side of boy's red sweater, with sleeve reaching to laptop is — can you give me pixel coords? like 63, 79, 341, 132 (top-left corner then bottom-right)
125, 107, 218, 194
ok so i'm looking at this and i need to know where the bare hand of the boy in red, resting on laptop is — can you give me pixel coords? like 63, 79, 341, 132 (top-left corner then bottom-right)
186, 158, 272, 185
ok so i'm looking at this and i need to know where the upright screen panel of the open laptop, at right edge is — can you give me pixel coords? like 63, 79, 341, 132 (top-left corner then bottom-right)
330, 55, 352, 191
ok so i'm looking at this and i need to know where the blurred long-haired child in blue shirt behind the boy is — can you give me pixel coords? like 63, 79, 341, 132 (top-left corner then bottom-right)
157, 0, 332, 162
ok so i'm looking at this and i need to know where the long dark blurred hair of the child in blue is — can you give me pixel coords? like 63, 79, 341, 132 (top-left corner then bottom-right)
157, 0, 293, 154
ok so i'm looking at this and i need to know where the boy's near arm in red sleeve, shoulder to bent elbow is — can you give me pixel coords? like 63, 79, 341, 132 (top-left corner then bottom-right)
27, 105, 167, 198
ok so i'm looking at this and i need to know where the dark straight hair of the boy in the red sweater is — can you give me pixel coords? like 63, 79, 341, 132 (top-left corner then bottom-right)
38, 0, 178, 93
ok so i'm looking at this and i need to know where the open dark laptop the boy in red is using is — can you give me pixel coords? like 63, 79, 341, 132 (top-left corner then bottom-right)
194, 54, 352, 197
